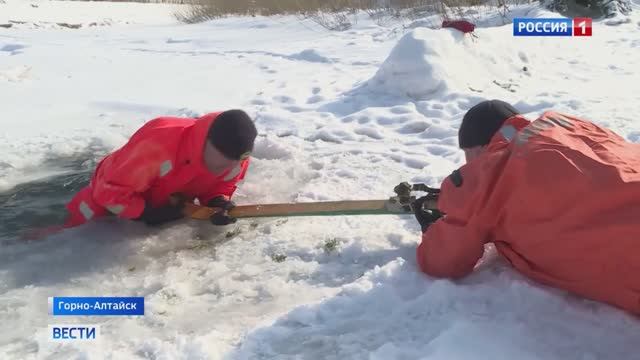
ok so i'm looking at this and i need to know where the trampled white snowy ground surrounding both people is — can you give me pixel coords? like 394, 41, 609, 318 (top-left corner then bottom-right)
0, 0, 640, 360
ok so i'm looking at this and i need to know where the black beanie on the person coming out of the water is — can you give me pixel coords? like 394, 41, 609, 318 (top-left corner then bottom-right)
208, 110, 258, 160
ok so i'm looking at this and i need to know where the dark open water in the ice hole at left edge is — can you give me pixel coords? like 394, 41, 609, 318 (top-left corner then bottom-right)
0, 155, 98, 244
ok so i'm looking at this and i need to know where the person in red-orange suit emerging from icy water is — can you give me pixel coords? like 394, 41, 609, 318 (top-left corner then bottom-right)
65, 110, 257, 227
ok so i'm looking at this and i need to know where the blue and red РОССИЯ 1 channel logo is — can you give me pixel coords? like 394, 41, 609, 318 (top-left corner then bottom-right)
513, 18, 593, 36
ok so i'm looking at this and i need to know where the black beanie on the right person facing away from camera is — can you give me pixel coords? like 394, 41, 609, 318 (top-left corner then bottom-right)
458, 100, 520, 148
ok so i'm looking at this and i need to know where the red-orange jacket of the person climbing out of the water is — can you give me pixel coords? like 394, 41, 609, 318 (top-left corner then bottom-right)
66, 112, 249, 227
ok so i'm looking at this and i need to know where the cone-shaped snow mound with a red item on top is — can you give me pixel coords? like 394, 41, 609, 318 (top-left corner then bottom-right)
365, 28, 526, 100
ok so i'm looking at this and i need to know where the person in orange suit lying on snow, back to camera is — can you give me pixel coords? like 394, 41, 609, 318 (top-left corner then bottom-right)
414, 100, 640, 314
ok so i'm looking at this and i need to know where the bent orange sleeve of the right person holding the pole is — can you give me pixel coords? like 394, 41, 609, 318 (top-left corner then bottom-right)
416, 166, 489, 279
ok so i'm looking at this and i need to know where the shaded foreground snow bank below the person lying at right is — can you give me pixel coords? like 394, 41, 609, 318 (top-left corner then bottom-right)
229, 259, 640, 360
